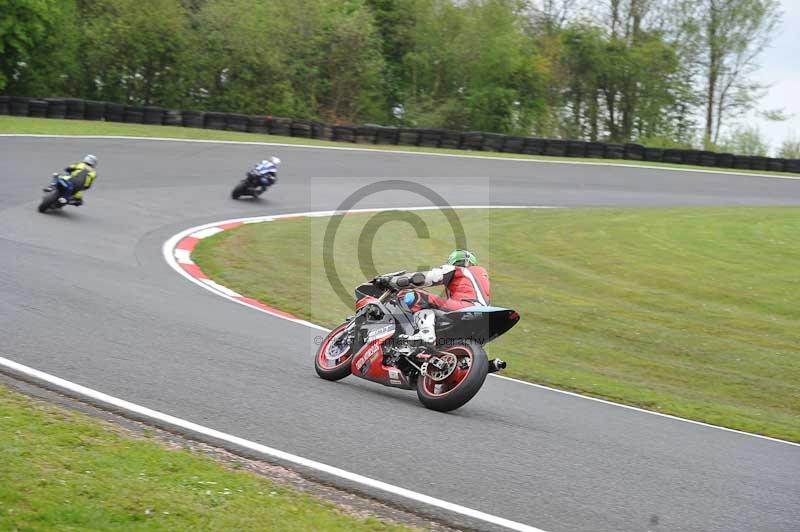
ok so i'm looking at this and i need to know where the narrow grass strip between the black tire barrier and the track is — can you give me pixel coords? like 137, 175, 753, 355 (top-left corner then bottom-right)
0, 116, 800, 179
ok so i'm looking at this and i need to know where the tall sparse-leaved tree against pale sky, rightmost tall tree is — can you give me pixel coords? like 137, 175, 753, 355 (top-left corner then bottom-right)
684, 0, 781, 146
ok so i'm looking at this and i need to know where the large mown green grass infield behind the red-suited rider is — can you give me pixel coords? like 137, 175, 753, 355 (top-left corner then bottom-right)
193, 208, 800, 441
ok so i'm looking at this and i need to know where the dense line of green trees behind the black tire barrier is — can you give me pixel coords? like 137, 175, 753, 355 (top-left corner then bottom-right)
0, 0, 797, 156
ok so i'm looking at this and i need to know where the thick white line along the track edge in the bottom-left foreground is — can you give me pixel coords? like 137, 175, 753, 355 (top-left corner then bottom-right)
0, 357, 544, 532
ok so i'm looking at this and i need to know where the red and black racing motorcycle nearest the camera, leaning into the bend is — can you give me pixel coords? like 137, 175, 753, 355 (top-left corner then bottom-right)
314, 271, 519, 412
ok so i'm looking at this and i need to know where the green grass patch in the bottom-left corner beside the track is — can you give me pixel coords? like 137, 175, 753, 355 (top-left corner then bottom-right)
0, 386, 405, 531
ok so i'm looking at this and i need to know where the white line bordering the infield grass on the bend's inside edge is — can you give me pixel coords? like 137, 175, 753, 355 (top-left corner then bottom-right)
162, 205, 800, 447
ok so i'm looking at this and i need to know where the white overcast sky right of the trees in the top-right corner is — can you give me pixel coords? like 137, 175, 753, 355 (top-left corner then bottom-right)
742, 0, 800, 154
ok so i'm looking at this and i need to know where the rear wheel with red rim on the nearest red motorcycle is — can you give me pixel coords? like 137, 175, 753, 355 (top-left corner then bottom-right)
417, 341, 489, 412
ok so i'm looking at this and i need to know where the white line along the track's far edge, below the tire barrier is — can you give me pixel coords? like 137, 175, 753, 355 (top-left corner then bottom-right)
0, 133, 800, 180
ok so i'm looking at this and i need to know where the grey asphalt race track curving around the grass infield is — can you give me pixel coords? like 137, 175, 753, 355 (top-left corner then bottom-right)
0, 137, 800, 532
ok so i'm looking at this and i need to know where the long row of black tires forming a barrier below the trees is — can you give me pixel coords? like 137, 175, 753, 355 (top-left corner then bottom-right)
0, 95, 800, 174
